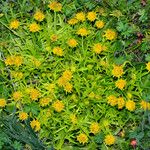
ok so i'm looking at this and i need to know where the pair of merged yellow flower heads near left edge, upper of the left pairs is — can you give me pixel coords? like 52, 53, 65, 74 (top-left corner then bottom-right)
5, 55, 23, 67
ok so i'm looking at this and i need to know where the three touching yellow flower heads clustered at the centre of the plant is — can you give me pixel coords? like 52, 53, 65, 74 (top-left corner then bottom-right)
58, 70, 73, 93
